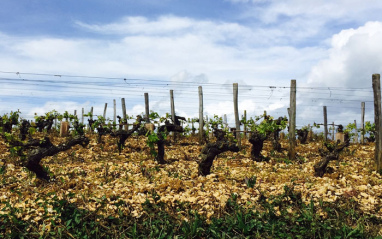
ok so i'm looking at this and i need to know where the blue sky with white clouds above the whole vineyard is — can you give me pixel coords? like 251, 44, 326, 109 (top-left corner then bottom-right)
0, 0, 382, 130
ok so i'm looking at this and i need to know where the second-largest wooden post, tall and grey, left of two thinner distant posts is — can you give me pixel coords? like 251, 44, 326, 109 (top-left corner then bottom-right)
289, 80, 296, 160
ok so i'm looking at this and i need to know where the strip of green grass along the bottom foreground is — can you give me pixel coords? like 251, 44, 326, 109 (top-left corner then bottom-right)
0, 186, 382, 238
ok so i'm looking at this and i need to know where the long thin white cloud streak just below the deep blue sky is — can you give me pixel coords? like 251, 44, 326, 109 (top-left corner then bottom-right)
76, 15, 321, 48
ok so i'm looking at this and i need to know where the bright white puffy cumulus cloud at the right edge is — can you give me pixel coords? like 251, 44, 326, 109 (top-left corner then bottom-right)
308, 22, 382, 88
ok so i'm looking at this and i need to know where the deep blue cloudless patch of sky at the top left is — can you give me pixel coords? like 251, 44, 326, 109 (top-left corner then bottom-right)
0, 0, 241, 37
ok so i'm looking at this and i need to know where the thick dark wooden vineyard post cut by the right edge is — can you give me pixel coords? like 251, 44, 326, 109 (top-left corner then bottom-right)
372, 74, 382, 173
